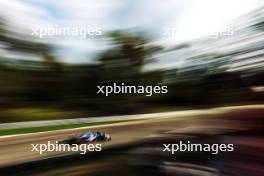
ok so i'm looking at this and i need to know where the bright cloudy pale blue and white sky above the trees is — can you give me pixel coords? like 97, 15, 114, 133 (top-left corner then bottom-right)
0, 0, 261, 63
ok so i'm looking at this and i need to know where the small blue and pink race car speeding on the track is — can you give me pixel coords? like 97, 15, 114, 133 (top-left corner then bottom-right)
59, 131, 111, 144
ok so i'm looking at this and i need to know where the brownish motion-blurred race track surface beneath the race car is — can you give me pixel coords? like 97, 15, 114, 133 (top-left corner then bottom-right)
0, 107, 264, 175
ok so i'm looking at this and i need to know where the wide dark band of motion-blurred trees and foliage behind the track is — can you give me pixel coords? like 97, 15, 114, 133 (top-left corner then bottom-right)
0, 17, 263, 122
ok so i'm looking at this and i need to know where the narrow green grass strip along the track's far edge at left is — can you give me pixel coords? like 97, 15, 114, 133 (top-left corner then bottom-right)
0, 120, 132, 136
